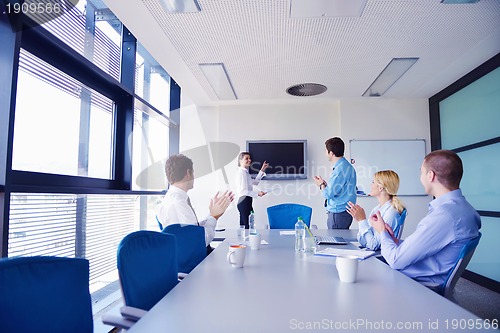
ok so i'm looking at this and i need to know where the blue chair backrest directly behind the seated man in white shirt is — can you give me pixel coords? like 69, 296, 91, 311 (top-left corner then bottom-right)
162, 223, 207, 273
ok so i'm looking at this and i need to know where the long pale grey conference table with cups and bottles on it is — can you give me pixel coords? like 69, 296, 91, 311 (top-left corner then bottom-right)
128, 229, 493, 333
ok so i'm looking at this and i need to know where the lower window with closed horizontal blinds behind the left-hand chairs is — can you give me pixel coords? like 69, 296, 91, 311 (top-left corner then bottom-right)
9, 193, 162, 292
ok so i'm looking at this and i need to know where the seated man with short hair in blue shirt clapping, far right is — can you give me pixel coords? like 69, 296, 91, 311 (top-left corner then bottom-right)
370, 150, 481, 287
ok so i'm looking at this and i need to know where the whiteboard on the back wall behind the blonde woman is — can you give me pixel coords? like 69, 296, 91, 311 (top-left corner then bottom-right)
349, 139, 426, 195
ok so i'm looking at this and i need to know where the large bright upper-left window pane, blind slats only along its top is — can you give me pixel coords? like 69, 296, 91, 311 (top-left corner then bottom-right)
12, 50, 114, 179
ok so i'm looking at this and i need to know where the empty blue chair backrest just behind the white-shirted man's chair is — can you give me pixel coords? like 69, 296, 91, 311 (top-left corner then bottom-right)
117, 230, 178, 311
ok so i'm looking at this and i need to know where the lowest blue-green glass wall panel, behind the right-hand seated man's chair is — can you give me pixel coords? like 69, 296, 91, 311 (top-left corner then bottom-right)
467, 216, 500, 281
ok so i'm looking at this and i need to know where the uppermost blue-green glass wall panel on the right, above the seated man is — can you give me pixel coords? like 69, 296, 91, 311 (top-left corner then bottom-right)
439, 68, 500, 149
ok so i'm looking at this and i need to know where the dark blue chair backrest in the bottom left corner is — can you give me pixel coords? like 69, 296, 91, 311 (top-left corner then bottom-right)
0, 256, 93, 333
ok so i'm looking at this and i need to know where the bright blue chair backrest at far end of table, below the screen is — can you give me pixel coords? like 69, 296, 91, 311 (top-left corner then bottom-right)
267, 203, 312, 229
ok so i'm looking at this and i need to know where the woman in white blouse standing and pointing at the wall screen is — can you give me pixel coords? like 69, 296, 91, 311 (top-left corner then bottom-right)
236, 152, 269, 229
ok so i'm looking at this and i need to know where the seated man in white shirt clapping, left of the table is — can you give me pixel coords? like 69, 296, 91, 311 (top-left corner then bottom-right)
156, 154, 234, 247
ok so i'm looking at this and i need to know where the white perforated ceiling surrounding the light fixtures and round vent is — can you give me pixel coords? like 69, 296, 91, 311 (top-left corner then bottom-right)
104, 0, 500, 105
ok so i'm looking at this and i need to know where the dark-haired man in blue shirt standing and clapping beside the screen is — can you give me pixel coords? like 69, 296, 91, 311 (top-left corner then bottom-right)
314, 137, 356, 229
